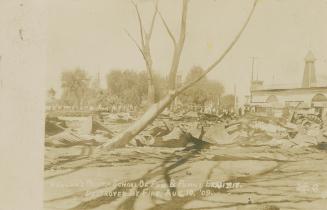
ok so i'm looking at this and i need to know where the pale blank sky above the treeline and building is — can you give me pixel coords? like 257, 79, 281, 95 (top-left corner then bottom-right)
47, 0, 327, 104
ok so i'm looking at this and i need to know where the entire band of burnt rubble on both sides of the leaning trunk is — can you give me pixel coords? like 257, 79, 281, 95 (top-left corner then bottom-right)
46, 110, 327, 152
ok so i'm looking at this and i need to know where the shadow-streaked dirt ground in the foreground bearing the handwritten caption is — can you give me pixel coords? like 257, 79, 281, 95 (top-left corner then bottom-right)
44, 137, 327, 210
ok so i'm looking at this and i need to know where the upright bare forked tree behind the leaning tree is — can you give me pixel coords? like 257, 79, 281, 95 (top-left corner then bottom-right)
126, 1, 158, 104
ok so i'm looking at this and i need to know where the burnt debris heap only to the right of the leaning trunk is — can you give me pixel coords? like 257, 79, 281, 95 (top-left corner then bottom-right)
133, 111, 327, 148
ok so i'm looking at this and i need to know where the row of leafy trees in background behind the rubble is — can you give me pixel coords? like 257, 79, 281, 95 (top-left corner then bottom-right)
48, 67, 234, 108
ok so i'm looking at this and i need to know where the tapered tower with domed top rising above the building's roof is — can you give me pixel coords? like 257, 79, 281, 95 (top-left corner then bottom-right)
302, 51, 317, 88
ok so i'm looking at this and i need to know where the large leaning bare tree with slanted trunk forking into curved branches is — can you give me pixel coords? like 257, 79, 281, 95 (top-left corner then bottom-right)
102, 0, 258, 149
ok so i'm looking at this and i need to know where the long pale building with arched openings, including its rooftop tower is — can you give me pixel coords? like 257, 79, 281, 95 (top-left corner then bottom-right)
249, 51, 327, 116
